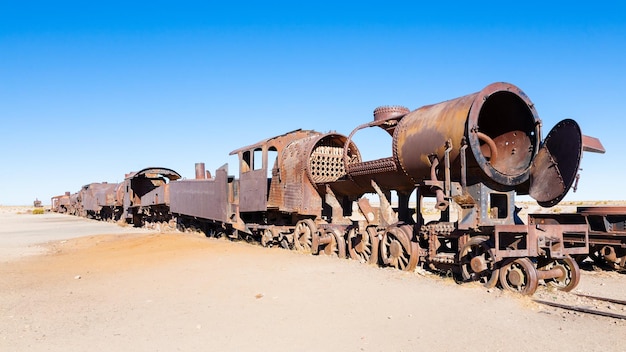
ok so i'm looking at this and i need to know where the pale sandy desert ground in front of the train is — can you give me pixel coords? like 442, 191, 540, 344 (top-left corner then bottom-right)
0, 209, 626, 351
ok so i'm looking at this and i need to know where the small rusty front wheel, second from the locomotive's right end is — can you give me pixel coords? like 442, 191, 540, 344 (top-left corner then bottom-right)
500, 258, 539, 296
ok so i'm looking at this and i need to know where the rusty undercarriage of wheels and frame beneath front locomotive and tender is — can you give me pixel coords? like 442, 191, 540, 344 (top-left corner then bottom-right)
175, 180, 589, 295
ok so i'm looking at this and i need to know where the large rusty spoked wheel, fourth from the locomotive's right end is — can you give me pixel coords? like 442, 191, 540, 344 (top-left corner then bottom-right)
380, 227, 419, 271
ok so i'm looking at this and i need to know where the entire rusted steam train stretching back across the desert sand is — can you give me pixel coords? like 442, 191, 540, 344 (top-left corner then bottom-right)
52, 83, 612, 294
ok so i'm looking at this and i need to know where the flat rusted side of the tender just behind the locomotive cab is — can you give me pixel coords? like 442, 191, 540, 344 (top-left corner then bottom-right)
169, 168, 229, 223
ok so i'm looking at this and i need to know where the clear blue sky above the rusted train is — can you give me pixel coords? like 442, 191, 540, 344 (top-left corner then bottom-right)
0, 0, 626, 205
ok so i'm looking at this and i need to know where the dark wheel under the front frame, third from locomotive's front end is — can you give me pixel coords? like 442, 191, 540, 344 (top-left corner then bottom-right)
459, 236, 500, 288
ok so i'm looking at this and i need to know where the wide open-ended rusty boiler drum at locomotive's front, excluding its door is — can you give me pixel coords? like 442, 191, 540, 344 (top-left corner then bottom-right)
393, 83, 541, 189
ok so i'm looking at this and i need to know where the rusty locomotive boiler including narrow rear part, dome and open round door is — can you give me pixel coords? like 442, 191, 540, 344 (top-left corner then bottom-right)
344, 82, 603, 206
